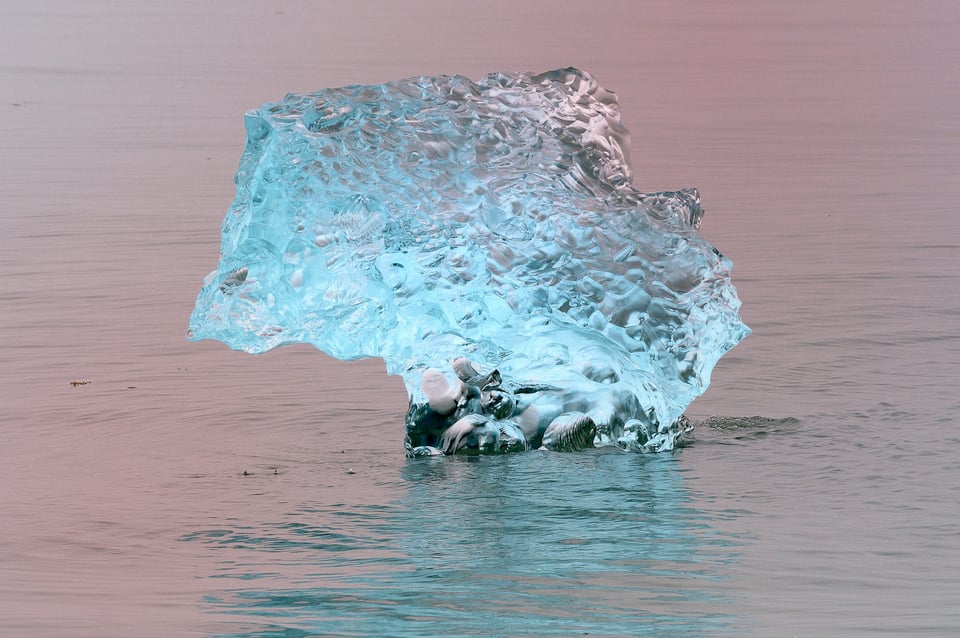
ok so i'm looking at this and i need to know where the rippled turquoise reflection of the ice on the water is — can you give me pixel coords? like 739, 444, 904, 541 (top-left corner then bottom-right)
183, 451, 738, 637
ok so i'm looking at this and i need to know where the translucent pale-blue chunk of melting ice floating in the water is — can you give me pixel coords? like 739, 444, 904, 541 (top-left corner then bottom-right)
188, 69, 749, 456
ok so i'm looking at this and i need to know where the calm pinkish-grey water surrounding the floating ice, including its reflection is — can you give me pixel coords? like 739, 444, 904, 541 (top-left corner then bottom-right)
0, 0, 960, 638
